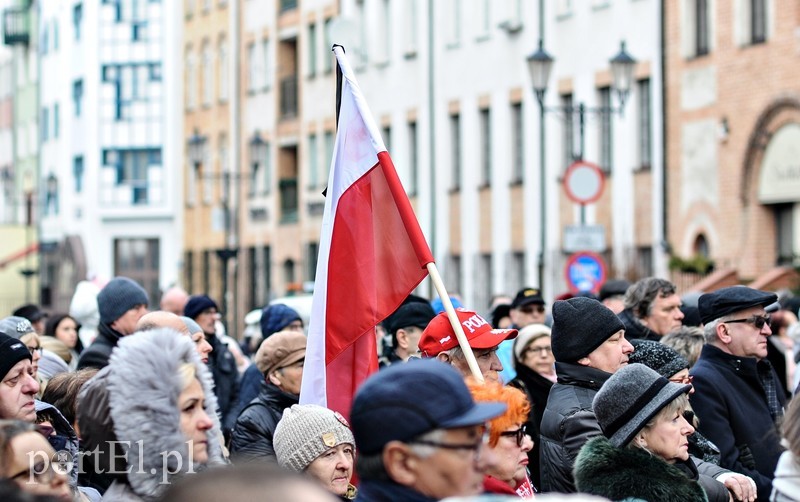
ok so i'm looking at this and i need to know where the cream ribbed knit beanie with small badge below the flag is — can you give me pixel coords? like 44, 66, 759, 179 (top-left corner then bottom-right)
272, 404, 356, 472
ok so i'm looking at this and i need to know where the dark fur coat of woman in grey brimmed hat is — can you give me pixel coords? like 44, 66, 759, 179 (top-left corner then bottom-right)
575, 437, 708, 502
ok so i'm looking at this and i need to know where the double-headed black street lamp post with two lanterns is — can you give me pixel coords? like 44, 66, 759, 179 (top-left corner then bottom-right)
527, 39, 636, 287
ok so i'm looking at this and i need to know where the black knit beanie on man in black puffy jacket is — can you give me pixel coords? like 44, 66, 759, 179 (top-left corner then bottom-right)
551, 296, 625, 363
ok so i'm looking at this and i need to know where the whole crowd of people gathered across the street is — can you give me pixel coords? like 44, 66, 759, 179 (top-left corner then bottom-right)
0, 277, 800, 502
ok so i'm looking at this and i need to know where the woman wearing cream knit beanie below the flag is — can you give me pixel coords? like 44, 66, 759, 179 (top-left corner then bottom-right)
273, 404, 356, 500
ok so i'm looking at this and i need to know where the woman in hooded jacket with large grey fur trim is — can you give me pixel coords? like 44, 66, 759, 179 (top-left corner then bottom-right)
78, 328, 225, 501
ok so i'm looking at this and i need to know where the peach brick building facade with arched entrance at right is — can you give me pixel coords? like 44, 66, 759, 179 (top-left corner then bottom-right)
665, 0, 800, 287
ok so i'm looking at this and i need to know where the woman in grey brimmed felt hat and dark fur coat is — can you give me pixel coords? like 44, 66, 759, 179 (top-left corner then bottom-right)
575, 363, 755, 502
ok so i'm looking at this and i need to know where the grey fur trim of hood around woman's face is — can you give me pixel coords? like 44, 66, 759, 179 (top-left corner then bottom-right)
107, 329, 225, 500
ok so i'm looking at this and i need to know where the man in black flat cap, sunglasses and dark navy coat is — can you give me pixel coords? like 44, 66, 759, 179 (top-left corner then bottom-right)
691, 286, 785, 500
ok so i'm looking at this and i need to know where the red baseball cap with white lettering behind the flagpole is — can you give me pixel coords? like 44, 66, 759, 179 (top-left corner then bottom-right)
419, 308, 517, 357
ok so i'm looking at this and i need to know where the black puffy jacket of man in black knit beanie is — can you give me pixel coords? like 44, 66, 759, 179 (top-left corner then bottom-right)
539, 362, 611, 493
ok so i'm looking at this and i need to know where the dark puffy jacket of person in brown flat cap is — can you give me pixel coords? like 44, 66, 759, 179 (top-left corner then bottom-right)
231, 381, 298, 463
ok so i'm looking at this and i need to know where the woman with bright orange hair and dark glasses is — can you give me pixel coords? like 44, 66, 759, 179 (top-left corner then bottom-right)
467, 379, 534, 498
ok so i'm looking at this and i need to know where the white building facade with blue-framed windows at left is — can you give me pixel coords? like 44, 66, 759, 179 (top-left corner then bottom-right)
39, 0, 182, 310
